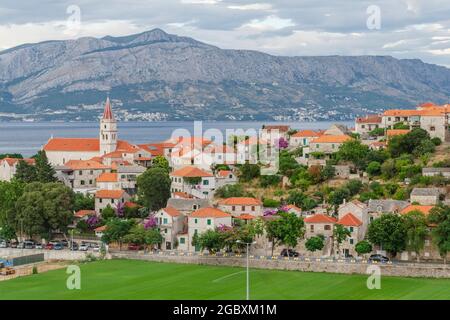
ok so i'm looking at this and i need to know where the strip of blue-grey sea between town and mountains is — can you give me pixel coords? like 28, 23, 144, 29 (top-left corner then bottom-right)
0, 121, 354, 157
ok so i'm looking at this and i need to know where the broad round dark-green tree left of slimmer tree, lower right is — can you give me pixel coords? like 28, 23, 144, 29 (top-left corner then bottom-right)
368, 213, 406, 256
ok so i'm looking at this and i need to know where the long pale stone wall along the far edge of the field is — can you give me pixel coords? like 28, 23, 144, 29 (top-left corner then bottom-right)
112, 252, 450, 278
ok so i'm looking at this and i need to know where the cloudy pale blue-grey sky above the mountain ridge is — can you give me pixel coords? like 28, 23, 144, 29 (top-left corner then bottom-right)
0, 0, 450, 67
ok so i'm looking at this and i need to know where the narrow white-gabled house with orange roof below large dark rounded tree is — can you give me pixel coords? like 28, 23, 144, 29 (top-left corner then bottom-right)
155, 207, 185, 250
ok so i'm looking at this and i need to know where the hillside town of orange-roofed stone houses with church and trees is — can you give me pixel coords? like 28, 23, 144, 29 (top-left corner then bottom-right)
0, 98, 450, 263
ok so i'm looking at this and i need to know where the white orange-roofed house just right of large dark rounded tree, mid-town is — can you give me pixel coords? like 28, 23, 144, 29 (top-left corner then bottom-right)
170, 166, 216, 199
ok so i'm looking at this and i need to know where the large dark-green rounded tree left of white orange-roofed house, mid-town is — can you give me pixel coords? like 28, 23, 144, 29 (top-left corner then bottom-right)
137, 168, 171, 211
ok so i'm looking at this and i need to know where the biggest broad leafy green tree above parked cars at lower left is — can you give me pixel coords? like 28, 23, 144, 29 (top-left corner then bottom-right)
14, 182, 73, 239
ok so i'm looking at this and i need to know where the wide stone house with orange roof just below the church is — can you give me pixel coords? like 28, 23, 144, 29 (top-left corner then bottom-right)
54, 160, 111, 193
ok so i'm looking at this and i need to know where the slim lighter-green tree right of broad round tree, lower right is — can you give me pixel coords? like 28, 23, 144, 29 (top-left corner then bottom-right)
403, 210, 428, 261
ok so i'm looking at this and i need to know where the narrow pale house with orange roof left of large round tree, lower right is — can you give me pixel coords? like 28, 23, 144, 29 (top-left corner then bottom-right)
336, 212, 367, 257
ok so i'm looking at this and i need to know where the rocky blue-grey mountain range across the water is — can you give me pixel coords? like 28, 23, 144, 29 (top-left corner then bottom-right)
0, 29, 450, 121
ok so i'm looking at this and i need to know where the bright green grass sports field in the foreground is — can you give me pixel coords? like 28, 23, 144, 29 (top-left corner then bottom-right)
0, 260, 450, 299
